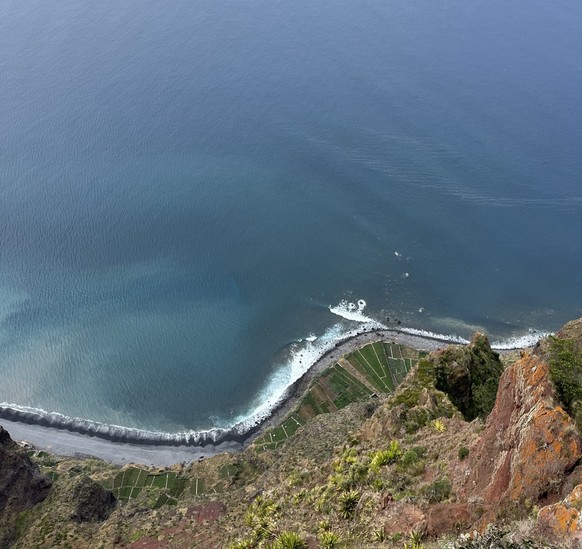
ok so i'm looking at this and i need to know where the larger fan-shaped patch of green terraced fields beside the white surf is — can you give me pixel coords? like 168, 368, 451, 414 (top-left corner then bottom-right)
254, 341, 426, 450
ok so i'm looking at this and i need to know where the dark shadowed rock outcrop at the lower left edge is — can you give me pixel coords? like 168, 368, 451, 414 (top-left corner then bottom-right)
0, 427, 52, 547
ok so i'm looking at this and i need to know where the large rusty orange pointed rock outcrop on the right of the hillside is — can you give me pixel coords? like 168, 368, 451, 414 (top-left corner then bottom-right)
455, 354, 582, 516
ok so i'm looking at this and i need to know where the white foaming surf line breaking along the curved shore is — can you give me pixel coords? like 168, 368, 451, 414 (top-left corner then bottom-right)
0, 300, 550, 446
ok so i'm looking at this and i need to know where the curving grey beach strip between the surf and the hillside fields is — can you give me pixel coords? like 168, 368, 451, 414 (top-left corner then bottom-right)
0, 328, 516, 466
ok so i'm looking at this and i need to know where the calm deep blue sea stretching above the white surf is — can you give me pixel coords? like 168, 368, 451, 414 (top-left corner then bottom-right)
0, 0, 582, 431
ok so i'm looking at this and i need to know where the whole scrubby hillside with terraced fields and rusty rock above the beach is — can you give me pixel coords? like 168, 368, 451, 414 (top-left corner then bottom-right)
0, 319, 582, 548
